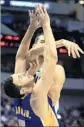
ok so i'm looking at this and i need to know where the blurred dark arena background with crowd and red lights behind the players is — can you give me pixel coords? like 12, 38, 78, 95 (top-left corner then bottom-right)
0, 0, 84, 127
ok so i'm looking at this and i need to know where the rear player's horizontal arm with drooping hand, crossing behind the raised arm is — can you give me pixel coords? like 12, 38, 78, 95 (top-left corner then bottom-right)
27, 39, 84, 63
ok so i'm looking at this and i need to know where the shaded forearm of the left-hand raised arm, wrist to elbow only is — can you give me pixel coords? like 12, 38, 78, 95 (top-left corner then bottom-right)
16, 25, 35, 58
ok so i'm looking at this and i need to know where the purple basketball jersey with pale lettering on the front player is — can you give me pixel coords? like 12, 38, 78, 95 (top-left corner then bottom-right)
14, 94, 56, 127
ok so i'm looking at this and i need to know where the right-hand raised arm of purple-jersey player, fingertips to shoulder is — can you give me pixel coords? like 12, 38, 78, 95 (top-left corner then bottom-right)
34, 7, 57, 94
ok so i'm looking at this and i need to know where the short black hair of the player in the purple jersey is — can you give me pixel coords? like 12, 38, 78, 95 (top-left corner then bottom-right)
4, 76, 24, 98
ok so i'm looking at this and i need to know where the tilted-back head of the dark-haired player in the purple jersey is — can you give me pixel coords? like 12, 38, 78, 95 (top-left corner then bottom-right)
4, 73, 34, 98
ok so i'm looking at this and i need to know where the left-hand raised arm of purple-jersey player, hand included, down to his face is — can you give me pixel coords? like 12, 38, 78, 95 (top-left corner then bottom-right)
15, 11, 40, 73
